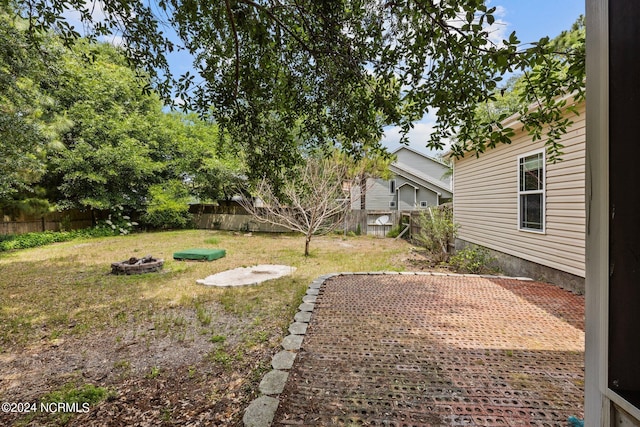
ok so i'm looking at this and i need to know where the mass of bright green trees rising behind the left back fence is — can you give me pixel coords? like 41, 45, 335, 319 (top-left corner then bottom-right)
0, 4, 246, 224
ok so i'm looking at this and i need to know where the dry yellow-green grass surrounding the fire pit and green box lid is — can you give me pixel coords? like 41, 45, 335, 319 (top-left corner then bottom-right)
0, 231, 406, 348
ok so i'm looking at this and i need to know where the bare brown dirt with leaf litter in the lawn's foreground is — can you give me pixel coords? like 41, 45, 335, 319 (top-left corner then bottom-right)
0, 309, 272, 426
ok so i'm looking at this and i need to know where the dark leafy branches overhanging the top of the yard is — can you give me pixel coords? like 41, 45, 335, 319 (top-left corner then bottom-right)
13, 0, 584, 160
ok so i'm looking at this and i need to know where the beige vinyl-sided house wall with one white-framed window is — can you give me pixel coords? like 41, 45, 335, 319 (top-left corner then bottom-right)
453, 102, 586, 290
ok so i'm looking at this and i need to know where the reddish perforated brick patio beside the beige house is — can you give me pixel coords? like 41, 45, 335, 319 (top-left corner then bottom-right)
273, 275, 584, 426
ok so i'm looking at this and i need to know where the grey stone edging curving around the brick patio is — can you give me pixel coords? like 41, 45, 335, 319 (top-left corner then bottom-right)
242, 271, 533, 427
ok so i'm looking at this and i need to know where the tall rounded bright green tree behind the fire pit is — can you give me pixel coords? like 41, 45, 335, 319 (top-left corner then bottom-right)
48, 41, 161, 209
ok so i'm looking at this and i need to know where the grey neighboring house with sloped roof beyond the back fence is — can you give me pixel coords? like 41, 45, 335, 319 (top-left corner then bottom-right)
351, 147, 452, 211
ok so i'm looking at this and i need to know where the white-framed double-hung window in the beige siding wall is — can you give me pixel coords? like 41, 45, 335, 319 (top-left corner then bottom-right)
518, 151, 545, 232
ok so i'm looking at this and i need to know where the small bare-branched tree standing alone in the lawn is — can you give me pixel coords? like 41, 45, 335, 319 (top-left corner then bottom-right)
242, 158, 350, 256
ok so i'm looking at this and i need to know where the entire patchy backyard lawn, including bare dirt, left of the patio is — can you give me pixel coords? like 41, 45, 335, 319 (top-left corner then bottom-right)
0, 230, 412, 426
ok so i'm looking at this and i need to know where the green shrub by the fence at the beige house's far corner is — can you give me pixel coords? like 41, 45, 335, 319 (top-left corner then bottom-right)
413, 206, 458, 262
